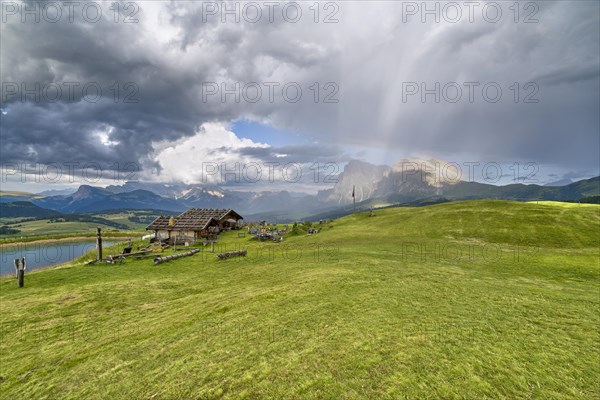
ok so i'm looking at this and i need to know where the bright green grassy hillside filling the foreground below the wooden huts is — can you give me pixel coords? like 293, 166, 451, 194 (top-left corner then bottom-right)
0, 201, 600, 399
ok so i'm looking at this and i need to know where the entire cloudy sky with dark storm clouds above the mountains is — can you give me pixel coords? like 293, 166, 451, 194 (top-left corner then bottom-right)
0, 0, 600, 191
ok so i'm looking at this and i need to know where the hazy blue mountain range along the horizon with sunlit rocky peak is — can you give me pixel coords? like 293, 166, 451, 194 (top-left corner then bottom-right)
0, 159, 600, 221
